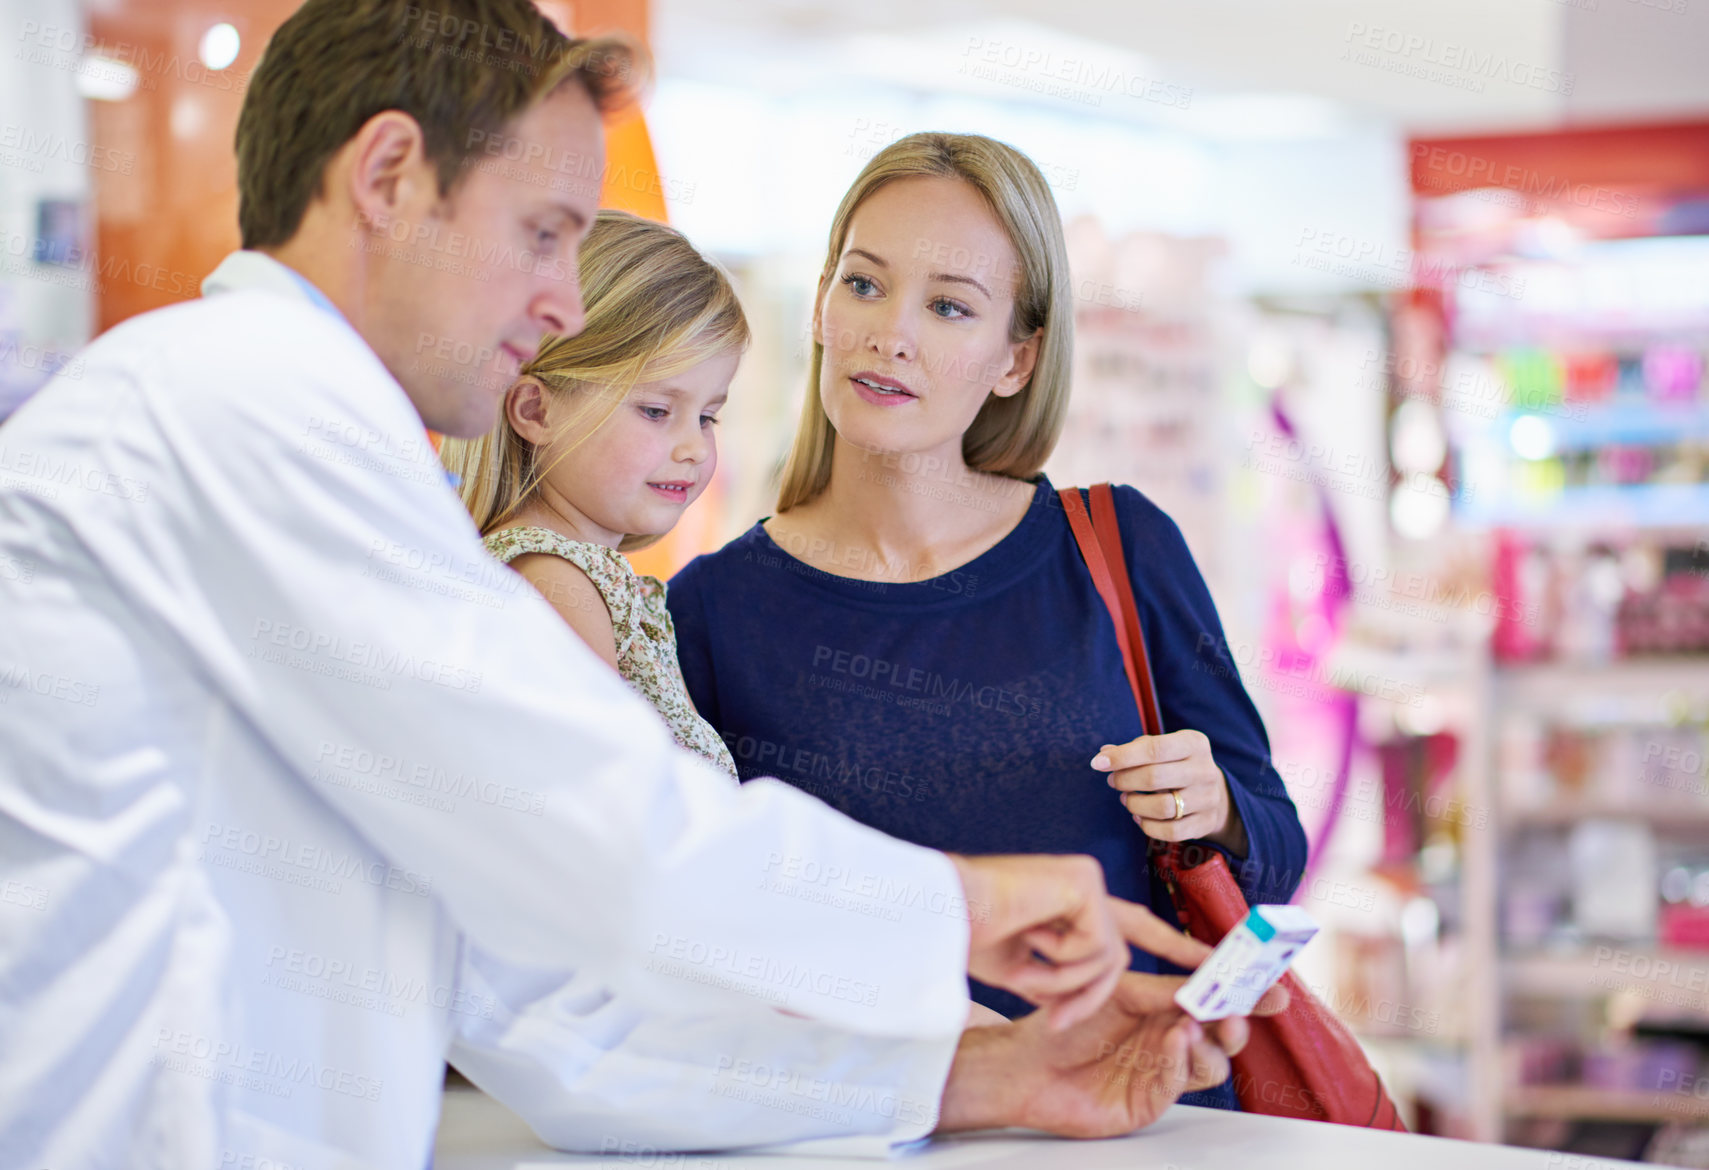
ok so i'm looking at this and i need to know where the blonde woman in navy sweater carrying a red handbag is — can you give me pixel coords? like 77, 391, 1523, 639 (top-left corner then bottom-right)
670, 133, 1306, 1109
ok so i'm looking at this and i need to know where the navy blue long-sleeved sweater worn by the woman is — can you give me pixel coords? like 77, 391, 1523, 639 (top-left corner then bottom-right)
668, 480, 1306, 1107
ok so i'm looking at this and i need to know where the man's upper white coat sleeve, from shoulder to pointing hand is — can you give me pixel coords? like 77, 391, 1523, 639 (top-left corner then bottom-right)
79, 292, 967, 1037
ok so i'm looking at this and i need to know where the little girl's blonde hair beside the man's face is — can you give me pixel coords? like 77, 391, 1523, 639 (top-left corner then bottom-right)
439, 210, 749, 552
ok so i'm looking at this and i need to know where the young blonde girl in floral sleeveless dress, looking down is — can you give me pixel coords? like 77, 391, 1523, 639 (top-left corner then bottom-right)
441, 210, 749, 777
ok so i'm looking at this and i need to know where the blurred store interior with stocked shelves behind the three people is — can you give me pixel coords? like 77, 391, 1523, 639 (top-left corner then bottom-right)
10, 0, 1709, 1165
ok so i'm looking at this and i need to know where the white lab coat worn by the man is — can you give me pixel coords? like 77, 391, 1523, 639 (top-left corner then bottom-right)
0, 253, 967, 1170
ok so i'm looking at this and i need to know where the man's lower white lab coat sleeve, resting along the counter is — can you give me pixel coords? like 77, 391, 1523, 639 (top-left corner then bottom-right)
449, 948, 959, 1158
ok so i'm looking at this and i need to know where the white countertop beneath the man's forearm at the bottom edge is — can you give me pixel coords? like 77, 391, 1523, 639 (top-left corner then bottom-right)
434, 1090, 1637, 1170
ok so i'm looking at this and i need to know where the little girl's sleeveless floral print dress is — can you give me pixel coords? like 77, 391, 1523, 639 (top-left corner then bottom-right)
487, 528, 737, 779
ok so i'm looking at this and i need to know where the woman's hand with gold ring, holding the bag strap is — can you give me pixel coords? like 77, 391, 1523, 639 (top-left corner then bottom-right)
1092, 731, 1246, 857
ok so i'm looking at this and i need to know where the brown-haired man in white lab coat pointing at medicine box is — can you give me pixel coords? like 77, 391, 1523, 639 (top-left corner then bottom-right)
0, 0, 1244, 1170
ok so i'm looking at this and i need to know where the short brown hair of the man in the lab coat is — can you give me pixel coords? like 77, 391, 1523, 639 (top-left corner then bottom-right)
238, 0, 644, 248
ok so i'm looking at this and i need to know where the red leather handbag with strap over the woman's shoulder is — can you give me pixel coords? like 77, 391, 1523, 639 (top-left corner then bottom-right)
1058, 483, 1407, 1131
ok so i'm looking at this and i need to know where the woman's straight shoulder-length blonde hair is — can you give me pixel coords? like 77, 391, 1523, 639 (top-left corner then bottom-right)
778, 133, 1073, 512
